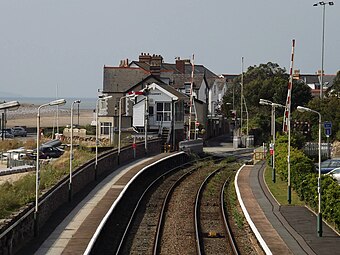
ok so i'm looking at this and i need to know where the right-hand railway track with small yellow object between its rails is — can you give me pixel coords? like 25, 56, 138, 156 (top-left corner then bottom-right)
195, 167, 239, 254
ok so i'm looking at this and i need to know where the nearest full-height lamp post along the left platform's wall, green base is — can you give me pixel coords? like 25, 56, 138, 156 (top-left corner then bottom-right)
34, 99, 66, 236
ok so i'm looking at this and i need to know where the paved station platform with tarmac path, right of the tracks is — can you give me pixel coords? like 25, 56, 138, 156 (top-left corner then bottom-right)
235, 161, 340, 255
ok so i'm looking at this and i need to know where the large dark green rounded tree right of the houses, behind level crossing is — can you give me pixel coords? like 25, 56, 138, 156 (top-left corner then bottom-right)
223, 62, 312, 142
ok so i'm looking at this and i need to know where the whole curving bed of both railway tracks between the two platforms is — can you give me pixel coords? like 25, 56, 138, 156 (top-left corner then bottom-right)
91, 154, 256, 254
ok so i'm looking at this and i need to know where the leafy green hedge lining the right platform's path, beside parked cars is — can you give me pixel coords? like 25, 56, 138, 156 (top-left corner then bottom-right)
275, 136, 340, 231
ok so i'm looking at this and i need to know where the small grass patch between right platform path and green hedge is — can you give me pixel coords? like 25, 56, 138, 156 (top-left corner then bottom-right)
264, 167, 305, 205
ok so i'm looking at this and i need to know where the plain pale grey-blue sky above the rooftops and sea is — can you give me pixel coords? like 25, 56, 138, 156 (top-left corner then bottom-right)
0, 0, 340, 99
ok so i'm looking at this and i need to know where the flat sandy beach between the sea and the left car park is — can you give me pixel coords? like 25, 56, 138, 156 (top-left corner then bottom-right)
6, 104, 94, 128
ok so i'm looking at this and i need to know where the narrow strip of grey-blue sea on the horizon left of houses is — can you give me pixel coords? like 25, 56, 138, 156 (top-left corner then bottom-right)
0, 97, 97, 110
